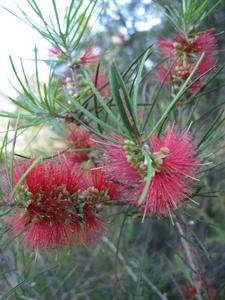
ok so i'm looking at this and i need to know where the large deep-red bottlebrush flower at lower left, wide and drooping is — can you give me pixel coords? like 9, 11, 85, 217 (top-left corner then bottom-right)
9, 160, 104, 250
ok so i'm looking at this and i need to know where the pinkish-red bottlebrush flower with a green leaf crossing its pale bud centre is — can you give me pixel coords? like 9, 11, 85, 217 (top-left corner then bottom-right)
106, 126, 199, 217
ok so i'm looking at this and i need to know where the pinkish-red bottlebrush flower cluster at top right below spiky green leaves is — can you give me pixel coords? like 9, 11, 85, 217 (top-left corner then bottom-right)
157, 32, 217, 92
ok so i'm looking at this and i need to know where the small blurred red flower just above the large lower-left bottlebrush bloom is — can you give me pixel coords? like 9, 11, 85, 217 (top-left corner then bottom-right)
65, 126, 95, 163
